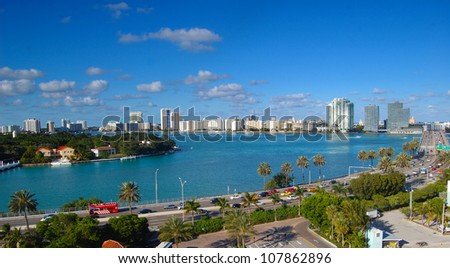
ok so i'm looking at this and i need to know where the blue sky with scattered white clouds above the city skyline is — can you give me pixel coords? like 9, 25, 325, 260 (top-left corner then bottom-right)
0, 0, 450, 126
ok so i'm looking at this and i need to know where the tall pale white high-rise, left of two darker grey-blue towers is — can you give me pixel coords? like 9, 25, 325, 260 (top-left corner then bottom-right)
326, 98, 355, 132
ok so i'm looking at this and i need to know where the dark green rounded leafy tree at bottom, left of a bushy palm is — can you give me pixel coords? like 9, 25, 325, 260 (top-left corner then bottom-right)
108, 214, 150, 247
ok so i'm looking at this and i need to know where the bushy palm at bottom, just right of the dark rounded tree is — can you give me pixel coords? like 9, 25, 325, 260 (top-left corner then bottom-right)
158, 216, 192, 247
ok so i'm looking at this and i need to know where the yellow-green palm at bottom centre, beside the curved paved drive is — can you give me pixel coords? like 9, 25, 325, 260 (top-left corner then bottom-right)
224, 209, 256, 247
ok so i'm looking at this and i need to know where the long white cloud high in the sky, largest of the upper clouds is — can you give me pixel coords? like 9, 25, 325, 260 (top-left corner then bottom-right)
119, 28, 222, 52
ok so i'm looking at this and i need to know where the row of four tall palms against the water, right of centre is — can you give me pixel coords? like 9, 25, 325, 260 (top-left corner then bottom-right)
256, 154, 326, 189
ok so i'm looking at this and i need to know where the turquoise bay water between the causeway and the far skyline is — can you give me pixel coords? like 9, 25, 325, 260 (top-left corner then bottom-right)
0, 134, 419, 211
